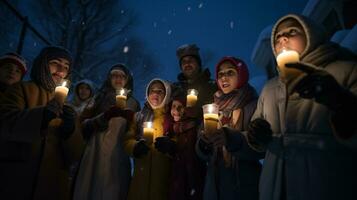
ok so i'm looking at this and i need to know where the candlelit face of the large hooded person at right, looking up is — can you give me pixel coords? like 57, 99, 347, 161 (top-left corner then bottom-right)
274, 21, 306, 54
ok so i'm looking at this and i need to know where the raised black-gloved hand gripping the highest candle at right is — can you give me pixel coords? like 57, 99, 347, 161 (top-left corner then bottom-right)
285, 62, 343, 110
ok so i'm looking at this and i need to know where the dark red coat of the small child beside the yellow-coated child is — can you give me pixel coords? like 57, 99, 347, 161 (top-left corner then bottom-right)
169, 112, 206, 200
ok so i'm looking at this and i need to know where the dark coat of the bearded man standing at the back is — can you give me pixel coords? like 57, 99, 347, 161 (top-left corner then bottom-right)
174, 68, 217, 108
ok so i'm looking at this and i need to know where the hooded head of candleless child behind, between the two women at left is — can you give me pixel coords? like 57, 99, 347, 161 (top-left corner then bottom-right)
72, 79, 94, 115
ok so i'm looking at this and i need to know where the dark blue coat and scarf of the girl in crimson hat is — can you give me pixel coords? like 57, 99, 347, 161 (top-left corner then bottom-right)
196, 84, 264, 200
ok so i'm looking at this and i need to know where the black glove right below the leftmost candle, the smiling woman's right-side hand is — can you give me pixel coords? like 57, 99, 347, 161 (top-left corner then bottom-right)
58, 105, 76, 140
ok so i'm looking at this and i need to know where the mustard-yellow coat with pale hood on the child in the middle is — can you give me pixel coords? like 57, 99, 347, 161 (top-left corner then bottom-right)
124, 79, 172, 200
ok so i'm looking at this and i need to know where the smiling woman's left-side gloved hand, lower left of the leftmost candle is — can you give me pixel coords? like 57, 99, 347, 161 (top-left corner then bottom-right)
41, 98, 62, 129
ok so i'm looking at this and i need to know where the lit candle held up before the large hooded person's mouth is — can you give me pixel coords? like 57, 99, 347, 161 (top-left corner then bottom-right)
276, 49, 301, 83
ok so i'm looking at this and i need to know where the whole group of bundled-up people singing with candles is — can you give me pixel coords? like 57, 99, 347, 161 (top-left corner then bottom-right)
0, 14, 357, 200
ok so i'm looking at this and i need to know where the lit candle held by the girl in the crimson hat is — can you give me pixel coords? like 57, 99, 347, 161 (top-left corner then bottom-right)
202, 104, 218, 135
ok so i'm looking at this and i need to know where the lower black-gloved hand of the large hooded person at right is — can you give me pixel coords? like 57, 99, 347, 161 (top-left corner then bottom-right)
247, 118, 273, 151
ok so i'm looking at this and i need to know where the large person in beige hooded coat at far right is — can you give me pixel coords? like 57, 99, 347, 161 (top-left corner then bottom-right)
248, 14, 357, 200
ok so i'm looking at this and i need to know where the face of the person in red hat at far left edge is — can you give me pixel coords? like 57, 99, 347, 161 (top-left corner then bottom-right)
0, 63, 22, 85
